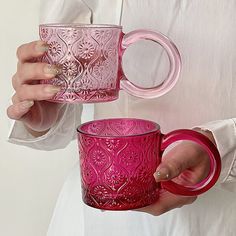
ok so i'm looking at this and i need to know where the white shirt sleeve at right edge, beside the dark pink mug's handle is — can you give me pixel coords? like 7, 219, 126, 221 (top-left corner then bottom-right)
198, 118, 236, 192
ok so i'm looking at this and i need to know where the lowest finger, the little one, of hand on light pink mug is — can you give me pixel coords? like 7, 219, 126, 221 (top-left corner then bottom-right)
7, 101, 34, 120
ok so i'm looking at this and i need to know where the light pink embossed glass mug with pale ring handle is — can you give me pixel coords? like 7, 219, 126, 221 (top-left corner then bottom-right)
39, 24, 181, 103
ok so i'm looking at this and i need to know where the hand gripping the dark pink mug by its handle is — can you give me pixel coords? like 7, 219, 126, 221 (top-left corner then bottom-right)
139, 130, 215, 216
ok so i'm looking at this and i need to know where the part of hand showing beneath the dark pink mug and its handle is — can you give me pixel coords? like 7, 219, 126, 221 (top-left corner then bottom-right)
138, 190, 197, 216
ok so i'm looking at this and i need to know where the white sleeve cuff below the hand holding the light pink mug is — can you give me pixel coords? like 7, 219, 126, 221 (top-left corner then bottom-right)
8, 104, 82, 151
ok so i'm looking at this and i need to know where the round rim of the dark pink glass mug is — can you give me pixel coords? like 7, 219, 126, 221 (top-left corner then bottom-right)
76, 118, 160, 138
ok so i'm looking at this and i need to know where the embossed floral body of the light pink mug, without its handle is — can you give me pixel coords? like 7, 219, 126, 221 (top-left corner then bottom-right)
40, 25, 121, 102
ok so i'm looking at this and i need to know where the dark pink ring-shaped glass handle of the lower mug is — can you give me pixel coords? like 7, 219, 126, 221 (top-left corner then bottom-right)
160, 129, 221, 196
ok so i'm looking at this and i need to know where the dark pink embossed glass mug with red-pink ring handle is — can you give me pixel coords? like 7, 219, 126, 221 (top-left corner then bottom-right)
77, 118, 221, 210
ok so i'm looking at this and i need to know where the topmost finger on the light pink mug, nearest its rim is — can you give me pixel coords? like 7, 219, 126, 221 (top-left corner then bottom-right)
16, 41, 48, 62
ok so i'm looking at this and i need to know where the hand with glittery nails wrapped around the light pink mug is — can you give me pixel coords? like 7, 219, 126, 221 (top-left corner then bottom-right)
7, 41, 61, 136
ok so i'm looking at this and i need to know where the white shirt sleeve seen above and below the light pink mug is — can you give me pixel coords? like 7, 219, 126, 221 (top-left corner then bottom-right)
8, 0, 96, 150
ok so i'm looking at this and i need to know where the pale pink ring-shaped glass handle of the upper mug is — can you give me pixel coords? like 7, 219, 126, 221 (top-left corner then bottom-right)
120, 30, 182, 98
